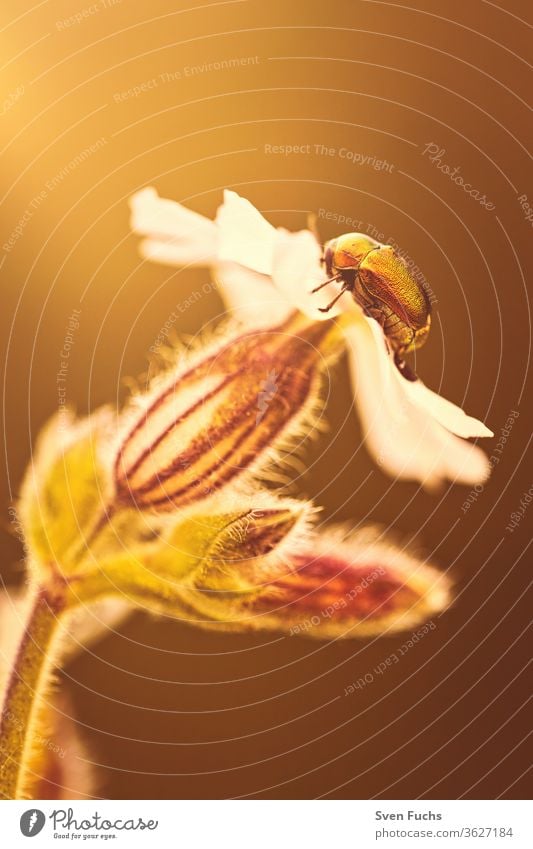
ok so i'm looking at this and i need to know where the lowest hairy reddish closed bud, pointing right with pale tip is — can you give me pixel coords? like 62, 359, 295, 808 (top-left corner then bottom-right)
174, 531, 450, 638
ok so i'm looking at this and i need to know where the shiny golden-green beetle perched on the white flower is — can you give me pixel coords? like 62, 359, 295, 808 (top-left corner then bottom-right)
313, 233, 431, 380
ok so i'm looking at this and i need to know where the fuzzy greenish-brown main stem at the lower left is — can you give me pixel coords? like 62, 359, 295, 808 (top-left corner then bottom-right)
0, 587, 65, 799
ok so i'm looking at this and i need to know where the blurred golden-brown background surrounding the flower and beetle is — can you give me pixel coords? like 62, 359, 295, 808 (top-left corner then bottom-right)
0, 0, 533, 799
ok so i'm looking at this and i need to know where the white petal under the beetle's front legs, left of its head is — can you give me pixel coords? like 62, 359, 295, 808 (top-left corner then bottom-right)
272, 230, 358, 321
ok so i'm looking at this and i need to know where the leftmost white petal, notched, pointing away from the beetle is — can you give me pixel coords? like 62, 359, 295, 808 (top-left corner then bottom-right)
130, 188, 218, 265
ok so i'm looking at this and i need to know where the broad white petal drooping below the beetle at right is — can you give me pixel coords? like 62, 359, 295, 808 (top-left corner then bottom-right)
346, 318, 490, 488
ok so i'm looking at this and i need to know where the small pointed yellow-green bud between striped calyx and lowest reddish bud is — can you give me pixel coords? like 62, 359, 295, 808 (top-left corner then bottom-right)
69, 496, 308, 618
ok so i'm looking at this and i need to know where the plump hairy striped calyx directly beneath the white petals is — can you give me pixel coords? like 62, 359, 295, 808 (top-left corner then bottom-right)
114, 315, 342, 510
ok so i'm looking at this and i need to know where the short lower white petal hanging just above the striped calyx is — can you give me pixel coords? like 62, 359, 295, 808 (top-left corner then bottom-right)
213, 262, 293, 327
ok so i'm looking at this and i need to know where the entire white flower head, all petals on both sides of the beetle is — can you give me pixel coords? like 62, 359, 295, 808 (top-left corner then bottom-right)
131, 188, 493, 488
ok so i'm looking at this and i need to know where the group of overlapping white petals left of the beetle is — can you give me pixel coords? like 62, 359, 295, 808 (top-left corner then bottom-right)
131, 188, 352, 325
